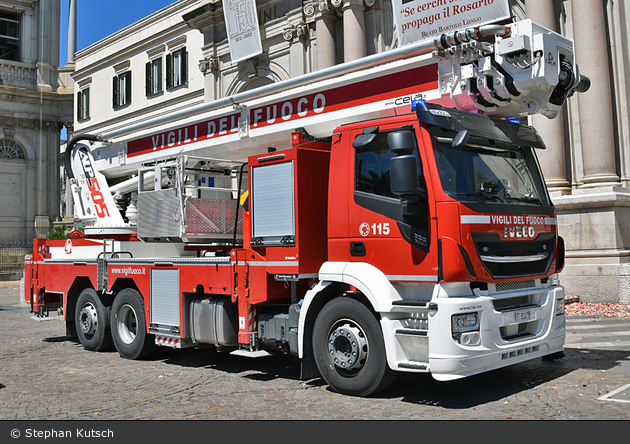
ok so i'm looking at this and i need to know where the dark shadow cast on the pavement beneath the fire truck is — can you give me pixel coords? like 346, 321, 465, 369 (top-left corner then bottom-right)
44, 337, 630, 408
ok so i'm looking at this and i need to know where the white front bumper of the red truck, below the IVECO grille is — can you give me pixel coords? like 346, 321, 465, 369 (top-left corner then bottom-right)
381, 286, 566, 381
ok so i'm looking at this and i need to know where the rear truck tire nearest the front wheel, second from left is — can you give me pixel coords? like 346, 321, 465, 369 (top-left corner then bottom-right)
111, 288, 157, 359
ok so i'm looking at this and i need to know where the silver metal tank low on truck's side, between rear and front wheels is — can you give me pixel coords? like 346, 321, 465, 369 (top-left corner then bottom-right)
190, 298, 238, 347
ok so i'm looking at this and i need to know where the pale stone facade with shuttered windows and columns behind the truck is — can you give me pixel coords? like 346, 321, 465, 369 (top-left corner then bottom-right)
69, 0, 630, 303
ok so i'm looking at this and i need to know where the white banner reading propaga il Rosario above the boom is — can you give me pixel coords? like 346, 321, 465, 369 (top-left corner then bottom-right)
393, 0, 510, 46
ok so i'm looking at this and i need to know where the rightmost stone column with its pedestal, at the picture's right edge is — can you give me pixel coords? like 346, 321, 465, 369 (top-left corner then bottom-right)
552, 0, 630, 304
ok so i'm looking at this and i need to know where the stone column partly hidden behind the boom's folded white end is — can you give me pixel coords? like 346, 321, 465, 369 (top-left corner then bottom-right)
525, 0, 571, 194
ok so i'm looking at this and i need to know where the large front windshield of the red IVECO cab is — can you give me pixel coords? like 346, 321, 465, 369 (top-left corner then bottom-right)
433, 128, 550, 206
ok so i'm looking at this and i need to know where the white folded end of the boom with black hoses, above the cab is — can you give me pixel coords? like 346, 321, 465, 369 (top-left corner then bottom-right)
436, 20, 590, 118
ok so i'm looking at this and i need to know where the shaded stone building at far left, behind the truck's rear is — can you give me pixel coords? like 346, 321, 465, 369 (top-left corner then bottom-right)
0, 0, 72, 244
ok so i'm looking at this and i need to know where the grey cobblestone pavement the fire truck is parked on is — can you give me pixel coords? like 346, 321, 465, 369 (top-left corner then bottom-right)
0, 282, 630, 421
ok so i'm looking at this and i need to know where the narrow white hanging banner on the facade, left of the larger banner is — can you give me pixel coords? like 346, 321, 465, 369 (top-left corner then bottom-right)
223, 0, 262, 62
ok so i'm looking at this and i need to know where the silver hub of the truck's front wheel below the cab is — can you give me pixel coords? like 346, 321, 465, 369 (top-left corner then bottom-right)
328, 321, 368, 371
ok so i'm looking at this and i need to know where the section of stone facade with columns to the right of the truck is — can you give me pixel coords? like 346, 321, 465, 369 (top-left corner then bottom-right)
525, 0, 630, 304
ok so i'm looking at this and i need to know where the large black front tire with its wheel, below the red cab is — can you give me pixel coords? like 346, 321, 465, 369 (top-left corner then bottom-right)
313, 297, 397, 396
